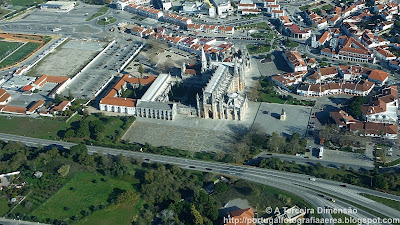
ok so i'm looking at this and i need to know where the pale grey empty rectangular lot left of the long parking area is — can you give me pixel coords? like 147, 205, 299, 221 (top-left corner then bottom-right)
28, 40, 105, 77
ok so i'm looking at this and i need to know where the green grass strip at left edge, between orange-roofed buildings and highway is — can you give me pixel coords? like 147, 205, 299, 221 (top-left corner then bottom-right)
0, 116, 66, 139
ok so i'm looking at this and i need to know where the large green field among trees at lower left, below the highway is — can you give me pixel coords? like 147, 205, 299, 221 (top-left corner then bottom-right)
32, 172, 136, 219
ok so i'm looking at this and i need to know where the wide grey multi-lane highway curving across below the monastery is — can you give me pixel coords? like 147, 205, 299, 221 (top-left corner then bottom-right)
0, 133, 400, 224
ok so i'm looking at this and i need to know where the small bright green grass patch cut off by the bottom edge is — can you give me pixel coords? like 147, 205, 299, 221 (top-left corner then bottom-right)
76, 199, 143, 225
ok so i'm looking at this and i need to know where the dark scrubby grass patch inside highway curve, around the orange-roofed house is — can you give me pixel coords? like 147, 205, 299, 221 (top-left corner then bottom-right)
213, 180, 318, 216
